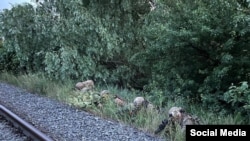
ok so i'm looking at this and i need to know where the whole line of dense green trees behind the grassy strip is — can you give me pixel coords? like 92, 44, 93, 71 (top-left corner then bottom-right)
0, 0, 250, 120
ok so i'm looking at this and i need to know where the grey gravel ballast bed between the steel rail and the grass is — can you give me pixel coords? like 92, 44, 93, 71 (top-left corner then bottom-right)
0, 83, 163, 141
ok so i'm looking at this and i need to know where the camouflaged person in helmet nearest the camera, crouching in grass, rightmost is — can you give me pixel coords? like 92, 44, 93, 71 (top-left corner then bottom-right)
155, 107, 200, 135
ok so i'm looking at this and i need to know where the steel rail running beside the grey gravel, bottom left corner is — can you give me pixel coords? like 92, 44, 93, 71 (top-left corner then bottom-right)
0, 105, 53, 141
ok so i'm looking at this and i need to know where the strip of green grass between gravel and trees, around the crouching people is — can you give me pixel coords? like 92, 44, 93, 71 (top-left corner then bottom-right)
0, 73, 245, 141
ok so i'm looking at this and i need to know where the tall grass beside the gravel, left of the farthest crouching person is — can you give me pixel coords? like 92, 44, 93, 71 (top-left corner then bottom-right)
0, 72, 73, 101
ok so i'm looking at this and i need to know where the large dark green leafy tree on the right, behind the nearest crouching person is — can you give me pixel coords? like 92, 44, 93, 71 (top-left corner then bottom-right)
141, 0, 250, 110
